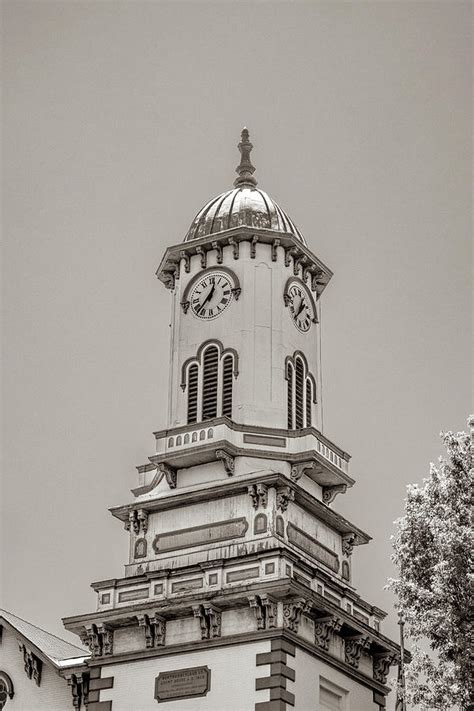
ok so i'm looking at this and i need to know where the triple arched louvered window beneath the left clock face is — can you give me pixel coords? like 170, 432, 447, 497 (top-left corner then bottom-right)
181, 341, 238, 424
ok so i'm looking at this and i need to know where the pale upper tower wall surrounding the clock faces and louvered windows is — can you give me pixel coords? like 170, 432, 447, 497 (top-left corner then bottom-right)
168, 242, 321, 428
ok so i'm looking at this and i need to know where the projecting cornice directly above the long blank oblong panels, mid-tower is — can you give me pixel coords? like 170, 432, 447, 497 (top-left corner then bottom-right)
109, 472, 371, 545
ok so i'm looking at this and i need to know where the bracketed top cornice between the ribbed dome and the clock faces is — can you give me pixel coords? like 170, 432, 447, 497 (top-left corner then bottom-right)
156, 225, 333, 297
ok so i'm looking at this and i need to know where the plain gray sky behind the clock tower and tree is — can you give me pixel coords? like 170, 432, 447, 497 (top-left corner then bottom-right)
2, 1, 472, 688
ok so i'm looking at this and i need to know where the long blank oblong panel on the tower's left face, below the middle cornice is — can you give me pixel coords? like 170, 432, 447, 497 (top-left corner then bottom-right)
153, 518, 248, 553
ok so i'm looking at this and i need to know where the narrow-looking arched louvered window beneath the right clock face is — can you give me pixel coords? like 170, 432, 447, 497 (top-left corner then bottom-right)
285, 351, 316, 430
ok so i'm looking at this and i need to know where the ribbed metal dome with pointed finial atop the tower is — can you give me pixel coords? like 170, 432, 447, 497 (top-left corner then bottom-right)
184, 128, 306, 244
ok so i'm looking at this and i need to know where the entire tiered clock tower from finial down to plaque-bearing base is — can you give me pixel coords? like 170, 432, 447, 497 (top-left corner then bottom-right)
64, 129, 399, 711
